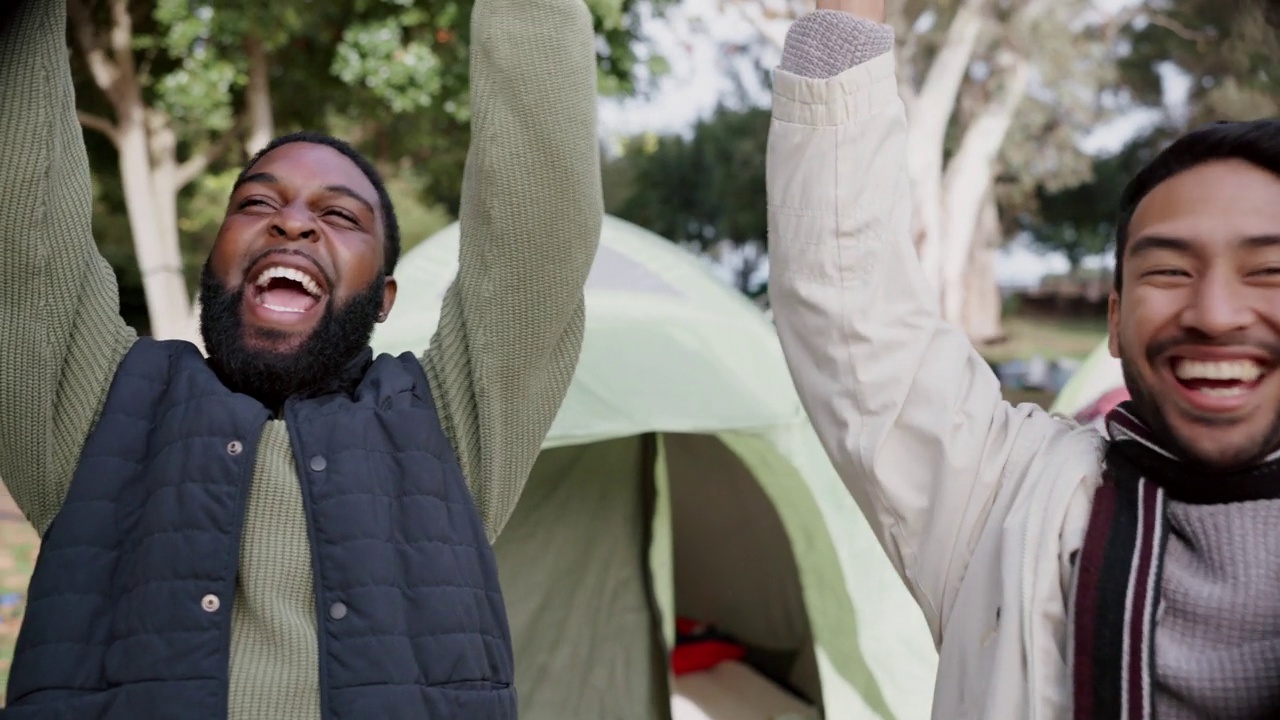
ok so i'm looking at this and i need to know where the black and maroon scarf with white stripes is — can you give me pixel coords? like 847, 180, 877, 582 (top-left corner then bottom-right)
1071, 402, 1280, 720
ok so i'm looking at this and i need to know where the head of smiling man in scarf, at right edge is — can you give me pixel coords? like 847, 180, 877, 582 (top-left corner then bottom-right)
1110, 152, 1280, 469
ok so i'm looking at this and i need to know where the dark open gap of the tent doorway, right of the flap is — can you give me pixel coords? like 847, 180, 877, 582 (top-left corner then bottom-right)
662, 434, 822, 707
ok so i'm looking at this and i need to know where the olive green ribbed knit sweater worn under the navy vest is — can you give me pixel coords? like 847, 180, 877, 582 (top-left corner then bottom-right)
0, 0, 603, 720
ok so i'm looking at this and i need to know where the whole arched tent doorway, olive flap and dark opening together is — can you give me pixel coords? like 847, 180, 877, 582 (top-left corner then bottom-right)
494, 434, 822, 720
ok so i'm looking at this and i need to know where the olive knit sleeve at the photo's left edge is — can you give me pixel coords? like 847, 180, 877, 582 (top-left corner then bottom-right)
0, 0, 134, 533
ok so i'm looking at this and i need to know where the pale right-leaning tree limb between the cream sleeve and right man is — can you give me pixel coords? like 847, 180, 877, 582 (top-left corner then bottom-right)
942, 55, 1030, 324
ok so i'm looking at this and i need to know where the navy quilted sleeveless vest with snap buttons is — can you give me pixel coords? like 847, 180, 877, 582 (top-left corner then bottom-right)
0, 340, 516, 720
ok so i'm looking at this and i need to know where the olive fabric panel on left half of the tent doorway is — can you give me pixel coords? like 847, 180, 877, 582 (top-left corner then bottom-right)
494, 436, 669, 720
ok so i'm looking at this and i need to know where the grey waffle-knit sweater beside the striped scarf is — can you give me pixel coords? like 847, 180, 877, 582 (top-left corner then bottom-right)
1155, 500, 1280, 720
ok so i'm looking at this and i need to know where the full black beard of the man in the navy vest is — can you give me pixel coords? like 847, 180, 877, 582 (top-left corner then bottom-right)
200, 263, 385, 411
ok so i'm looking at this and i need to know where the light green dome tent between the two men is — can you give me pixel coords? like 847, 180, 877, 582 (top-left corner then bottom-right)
374, 217, 937, 720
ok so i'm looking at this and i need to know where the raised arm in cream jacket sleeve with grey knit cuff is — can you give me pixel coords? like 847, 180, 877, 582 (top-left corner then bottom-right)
768, 7, 1065, 642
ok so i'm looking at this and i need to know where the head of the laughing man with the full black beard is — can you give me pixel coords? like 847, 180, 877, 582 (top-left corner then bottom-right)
200, 139, 399, 407
